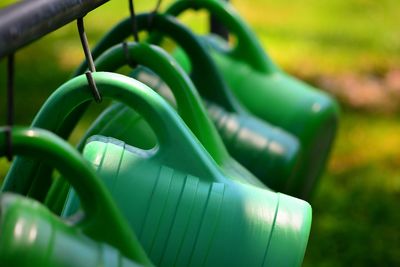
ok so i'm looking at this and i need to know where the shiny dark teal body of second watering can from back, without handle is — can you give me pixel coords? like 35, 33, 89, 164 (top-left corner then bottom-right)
131, 67, 299, 192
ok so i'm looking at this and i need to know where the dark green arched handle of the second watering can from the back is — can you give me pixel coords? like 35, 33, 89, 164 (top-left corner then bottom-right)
76, 14, 241, 111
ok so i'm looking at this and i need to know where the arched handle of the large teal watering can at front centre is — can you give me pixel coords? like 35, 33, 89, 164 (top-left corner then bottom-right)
5, 72, 221, 198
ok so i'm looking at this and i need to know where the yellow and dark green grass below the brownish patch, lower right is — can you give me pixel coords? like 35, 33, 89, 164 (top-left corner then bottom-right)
304, 110, 400, 266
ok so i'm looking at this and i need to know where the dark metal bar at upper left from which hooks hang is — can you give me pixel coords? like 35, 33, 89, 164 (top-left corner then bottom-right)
0, 0, 109, 58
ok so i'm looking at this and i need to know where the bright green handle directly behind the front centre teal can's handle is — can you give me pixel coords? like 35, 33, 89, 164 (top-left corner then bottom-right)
95, 43, 228, 163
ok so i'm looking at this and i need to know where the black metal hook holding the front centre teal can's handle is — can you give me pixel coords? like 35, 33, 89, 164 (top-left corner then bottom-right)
77, 18, 102, 103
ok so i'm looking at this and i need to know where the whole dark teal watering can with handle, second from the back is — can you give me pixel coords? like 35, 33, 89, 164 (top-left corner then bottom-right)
73, 14, 300, 195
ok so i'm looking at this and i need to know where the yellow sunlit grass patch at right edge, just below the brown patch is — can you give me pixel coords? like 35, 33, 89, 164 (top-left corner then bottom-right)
330, 113, 400, 177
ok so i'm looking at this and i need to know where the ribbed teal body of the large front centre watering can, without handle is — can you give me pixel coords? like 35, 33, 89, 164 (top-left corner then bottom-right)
65, 135, 311, 266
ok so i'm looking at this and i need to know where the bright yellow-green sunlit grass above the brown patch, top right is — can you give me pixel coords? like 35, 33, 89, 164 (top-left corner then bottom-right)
233, 0, 400, 73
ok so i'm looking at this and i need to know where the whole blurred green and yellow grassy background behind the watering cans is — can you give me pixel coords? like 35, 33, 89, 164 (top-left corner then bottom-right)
0, 0, 400, 266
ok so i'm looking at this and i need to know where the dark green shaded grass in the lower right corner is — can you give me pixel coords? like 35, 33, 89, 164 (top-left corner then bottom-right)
304, 166, 400, 266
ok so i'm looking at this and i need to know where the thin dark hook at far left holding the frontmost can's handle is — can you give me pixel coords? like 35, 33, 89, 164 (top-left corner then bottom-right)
6, 54, 14, 162
